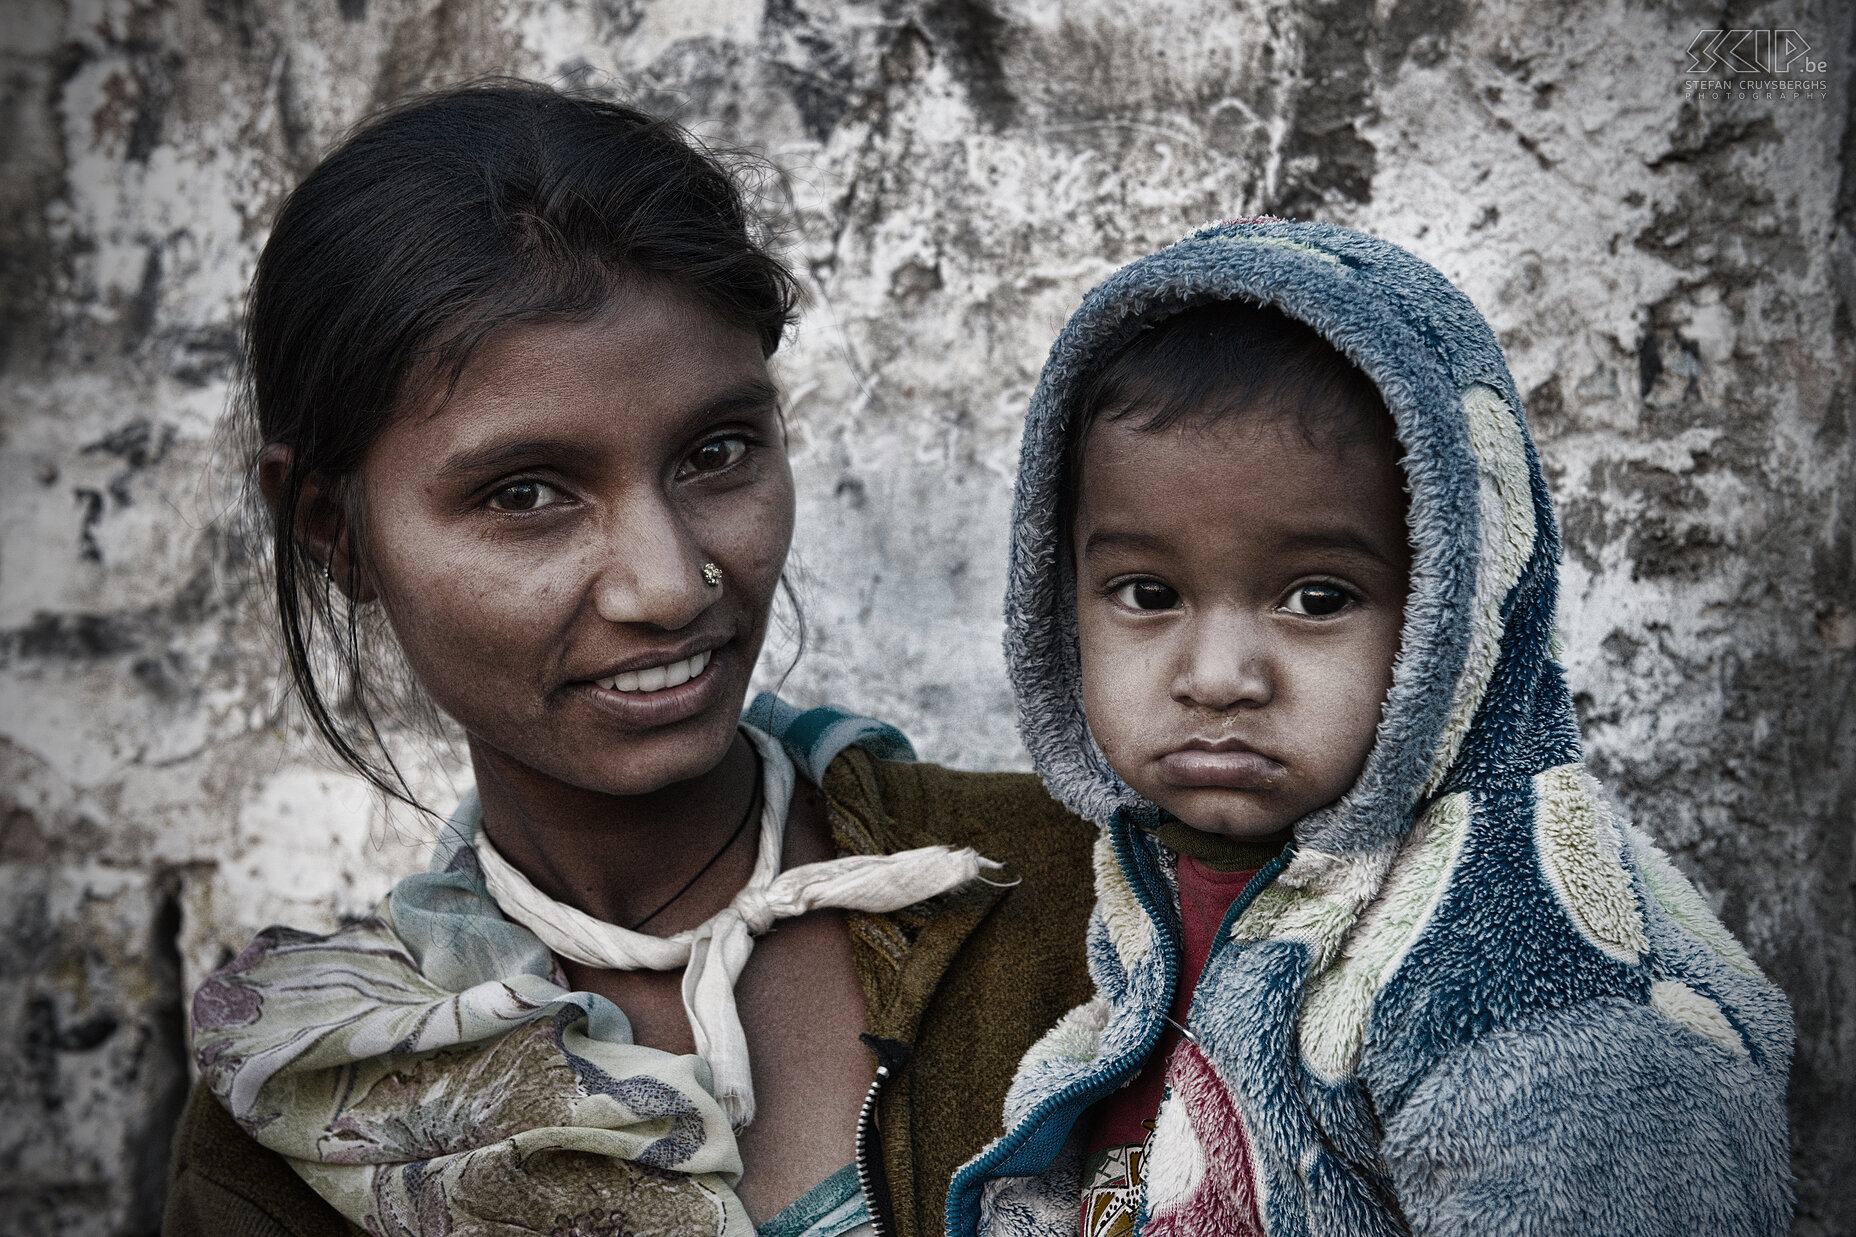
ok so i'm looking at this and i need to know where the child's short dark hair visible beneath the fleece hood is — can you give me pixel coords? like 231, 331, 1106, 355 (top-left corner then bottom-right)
1062, 301, 1398, 509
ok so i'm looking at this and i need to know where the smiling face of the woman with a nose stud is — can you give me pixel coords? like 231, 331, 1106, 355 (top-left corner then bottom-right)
348, 284, 793, 795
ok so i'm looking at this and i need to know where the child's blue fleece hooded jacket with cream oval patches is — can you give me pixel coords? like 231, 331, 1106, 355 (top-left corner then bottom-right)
947, 219, 1791, 1237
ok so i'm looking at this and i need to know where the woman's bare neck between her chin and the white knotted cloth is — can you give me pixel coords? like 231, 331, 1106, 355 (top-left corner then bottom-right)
471, 732, 759, 934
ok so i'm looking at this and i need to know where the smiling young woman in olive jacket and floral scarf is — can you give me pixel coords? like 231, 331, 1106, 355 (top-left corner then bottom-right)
165, 84, 1091, 1237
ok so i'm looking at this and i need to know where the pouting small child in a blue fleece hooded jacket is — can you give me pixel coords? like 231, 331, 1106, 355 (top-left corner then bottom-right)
947, 219, 1791, 1237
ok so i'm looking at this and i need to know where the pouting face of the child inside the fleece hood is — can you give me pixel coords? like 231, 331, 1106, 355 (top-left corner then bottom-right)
1073, 412, 1411, 838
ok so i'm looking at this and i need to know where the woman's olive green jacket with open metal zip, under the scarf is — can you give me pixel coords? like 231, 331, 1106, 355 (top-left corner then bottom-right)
161, 749, 1095, 1237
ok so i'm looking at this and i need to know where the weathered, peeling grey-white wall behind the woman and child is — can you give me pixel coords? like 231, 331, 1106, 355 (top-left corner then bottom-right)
0, 0, 1856, 1235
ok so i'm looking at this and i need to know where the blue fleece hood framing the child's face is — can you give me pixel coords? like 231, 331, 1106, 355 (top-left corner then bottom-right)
1006, 221, 1579, 851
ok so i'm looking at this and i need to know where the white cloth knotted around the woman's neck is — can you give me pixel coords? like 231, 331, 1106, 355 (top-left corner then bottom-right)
473, 726, 1000, 1129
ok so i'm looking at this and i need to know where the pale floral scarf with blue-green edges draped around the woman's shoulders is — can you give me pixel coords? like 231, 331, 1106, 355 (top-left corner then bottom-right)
193, 697, 913, 1237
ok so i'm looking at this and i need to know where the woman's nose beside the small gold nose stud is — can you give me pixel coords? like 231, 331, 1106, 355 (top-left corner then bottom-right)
592, 503, 726, 632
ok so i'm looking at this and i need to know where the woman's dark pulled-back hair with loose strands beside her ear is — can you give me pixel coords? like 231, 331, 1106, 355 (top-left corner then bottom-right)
241, 80, 798, 802
